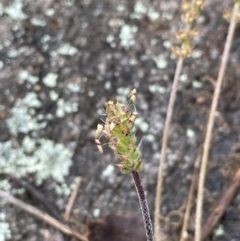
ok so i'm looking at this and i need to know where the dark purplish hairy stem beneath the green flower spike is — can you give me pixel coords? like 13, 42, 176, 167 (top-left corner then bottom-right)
131, 171, 154, 241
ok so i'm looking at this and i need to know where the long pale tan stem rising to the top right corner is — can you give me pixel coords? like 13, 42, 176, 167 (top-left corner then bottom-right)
195, 1, 240, 241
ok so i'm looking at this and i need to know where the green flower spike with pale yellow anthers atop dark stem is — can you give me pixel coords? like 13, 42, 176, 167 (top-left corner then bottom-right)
95, 89, 143, 173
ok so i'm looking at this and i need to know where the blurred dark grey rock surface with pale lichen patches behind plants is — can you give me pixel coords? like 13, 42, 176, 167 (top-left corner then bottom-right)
0, 0, 240, 241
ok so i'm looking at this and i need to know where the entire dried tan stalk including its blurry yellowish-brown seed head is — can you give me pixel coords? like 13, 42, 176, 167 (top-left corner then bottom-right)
154, 0, 204, 238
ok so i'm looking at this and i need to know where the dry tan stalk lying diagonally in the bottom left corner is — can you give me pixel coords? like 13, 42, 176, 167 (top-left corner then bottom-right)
0, 190, 88, 241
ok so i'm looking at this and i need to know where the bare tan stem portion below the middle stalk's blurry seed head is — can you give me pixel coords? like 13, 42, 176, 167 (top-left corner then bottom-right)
154, 57, 184, 241
